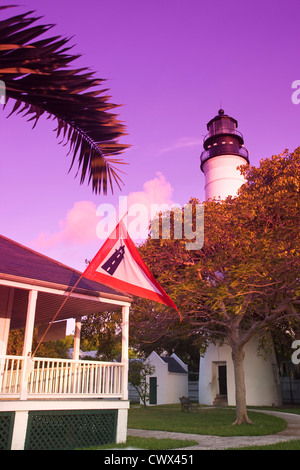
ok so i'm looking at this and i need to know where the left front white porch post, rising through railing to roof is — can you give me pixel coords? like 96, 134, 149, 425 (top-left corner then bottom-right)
20, 290, 38, 400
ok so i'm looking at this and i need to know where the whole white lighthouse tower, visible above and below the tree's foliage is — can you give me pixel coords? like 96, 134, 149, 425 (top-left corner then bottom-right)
199, 109, 282, 406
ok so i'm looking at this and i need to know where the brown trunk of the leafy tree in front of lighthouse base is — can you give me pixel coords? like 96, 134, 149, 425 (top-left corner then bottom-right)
232, 347, 253, 424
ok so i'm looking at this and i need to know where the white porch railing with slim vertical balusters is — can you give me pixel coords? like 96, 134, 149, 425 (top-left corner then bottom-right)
0, 356, 124, 400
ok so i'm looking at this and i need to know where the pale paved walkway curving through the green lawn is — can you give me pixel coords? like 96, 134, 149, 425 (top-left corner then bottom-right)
128, 410, 300, 450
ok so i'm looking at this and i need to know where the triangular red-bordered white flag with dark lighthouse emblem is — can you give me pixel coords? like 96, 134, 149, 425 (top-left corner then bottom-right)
83, 220, 177, 310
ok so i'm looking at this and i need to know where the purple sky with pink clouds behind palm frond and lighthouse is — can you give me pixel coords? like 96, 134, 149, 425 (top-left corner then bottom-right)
0, 0, 300, 270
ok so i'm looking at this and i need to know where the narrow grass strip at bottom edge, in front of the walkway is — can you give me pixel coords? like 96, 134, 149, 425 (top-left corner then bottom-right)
87, 436, 197, 450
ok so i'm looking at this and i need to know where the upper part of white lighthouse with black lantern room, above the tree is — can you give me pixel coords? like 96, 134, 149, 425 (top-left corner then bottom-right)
200, 109, 249, 200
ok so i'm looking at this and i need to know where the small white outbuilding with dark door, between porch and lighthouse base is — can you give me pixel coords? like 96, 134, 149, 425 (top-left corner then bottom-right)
146, 351, 188, 405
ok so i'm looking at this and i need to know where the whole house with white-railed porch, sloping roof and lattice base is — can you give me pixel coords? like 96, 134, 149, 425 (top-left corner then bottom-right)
0, 236, 132, 450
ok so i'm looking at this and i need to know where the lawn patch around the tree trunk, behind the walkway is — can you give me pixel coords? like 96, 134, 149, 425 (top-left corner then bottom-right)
128, 405, 287, 436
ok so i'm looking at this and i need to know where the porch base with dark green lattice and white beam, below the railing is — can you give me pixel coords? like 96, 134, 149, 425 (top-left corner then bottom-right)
0, 398, 129, 450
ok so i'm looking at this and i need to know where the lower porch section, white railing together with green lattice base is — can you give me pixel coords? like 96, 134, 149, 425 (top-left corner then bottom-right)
0, 350, 129, 450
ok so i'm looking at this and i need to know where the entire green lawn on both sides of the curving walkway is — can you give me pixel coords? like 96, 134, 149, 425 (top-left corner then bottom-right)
81, 405, 300, 450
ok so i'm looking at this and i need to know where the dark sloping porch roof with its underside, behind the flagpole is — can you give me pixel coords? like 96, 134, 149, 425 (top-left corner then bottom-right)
0, 235, 132, 329
